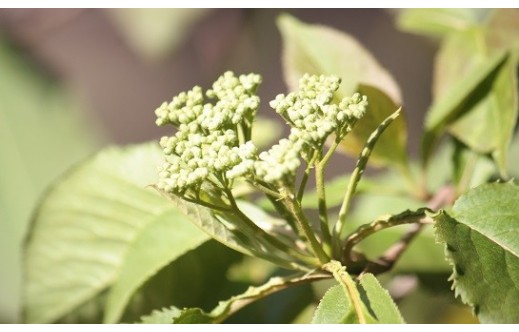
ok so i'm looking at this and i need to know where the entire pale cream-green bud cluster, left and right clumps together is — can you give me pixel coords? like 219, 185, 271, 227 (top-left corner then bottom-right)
155, 72, 367, 193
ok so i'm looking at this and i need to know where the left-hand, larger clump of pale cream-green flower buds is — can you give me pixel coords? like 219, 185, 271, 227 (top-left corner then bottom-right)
155, 72, 261, 193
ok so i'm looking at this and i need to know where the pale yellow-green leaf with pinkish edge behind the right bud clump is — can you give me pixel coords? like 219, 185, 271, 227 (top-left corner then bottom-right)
278, 15, 407, 169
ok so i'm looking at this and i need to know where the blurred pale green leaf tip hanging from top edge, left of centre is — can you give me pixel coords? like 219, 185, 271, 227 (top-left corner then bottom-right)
106, 8, 209, 60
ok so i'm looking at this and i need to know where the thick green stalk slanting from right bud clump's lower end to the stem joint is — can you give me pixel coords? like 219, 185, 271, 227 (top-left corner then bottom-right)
283, 187, 330, 264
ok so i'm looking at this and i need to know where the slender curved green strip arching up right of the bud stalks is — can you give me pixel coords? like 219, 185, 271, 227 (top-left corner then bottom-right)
333, 108, 401, 255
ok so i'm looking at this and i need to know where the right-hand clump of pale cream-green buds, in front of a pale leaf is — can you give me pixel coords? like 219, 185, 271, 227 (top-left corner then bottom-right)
256, 74, 367, 182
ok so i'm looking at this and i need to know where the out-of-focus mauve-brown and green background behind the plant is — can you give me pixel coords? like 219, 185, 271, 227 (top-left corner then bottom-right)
0, 9, 437, 323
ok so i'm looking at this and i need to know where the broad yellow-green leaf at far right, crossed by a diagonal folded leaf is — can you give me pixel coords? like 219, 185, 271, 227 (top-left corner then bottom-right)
433, 28, 518, 174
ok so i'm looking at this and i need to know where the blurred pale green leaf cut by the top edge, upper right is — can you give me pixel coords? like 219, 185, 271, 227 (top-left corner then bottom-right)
397, 8, 486, 37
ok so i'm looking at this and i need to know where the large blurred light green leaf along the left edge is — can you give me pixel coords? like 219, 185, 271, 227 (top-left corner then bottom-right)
0, 36, 102, 322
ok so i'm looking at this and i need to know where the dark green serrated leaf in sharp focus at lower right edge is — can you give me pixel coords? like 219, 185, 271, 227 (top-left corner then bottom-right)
435, 183, 519, 323
